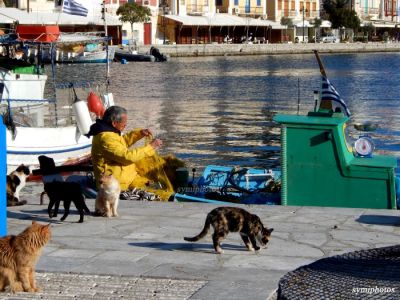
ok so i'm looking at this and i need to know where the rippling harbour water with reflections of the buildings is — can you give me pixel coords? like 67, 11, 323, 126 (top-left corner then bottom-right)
49, 53, 400, 171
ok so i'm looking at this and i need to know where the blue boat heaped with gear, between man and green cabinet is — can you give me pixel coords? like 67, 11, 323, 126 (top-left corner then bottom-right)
174, 165, 281, 204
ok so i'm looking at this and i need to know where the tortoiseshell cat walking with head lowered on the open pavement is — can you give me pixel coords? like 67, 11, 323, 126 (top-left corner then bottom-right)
184, 207, 274, 253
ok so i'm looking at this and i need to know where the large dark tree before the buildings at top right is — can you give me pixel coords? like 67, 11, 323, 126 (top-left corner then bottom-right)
324, 0, 360, 30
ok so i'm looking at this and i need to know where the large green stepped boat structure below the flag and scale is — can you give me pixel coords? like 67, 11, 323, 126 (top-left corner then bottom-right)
274, 114, 397, 208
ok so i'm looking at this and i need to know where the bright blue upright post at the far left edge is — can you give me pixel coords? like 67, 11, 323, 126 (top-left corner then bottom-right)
0, 117, 7, 237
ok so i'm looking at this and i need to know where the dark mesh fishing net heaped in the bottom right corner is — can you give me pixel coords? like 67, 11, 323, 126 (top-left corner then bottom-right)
278, 245, 400, 300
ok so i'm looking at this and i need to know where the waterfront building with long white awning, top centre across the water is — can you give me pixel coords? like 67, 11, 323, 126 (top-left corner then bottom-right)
158, 0, 286, 44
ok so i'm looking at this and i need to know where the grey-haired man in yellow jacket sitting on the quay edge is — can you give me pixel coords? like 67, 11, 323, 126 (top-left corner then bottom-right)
87, 106, 162, 195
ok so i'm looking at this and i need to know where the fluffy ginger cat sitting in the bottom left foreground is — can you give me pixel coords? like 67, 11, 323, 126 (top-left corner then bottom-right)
0, 221, 51, 293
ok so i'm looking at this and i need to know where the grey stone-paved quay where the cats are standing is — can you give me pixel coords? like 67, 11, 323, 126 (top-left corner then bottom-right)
0, 183, 400, 300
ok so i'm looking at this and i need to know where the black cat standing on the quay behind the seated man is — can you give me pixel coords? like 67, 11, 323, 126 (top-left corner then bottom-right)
44, 181, 90, 223
